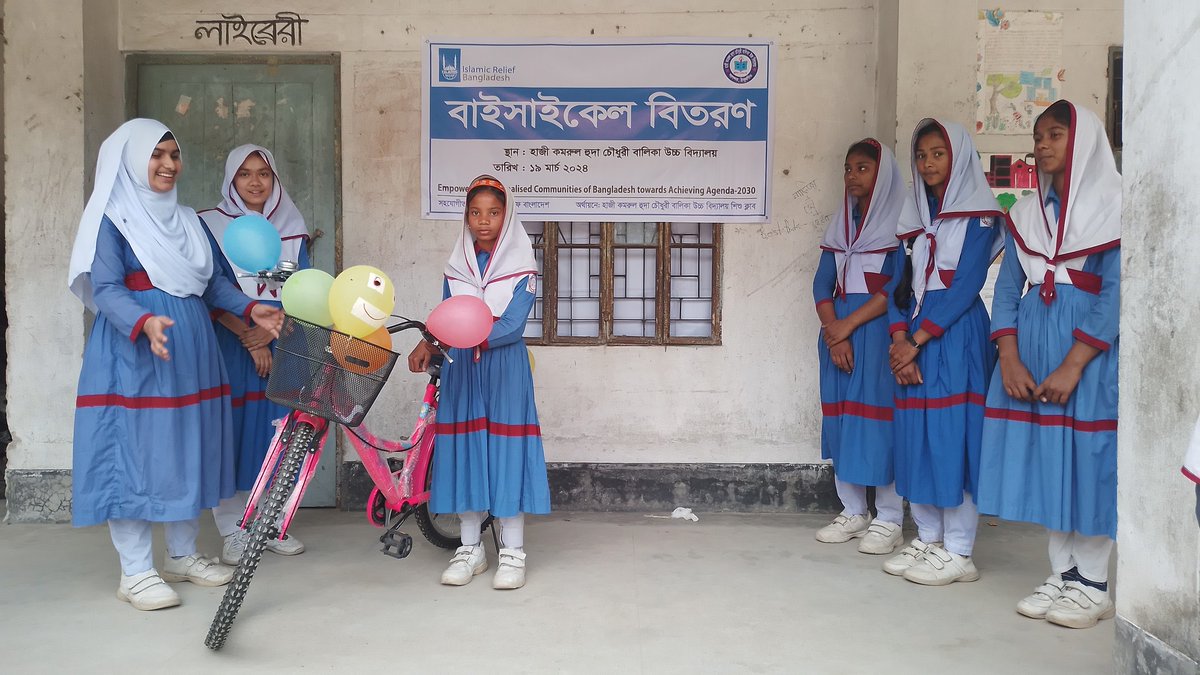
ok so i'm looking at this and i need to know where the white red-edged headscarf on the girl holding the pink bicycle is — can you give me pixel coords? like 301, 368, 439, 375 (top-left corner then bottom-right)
445, 175, 538, 317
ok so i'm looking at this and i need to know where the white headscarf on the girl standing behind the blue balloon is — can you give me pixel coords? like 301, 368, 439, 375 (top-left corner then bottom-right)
200, 143, 308, 300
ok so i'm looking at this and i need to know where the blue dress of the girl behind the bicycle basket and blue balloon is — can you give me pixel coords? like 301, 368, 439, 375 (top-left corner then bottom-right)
212, 239, 312, 491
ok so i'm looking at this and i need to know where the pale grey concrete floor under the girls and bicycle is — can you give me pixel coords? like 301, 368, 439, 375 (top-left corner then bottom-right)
0, 510, 1114, 675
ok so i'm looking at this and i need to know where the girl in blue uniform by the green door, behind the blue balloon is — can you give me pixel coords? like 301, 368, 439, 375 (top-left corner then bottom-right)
199, 144, 311, 565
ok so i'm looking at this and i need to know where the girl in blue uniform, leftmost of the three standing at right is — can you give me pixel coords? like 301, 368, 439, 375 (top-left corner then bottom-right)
812, 138, 908, 555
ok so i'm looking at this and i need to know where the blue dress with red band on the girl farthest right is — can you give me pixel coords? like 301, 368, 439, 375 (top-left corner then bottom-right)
978, 192, 1121, 538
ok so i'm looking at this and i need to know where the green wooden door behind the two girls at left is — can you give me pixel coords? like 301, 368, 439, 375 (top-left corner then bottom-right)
134, 58, 340, 507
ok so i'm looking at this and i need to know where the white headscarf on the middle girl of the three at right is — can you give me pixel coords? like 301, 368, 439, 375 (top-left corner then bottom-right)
896, 118, 1004, 316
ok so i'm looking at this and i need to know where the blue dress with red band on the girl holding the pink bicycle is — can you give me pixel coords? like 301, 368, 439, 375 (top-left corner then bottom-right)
430, 251, 550, 518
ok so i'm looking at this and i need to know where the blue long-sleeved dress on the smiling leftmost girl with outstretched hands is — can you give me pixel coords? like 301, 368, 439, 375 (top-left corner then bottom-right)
72, 217, 252, 527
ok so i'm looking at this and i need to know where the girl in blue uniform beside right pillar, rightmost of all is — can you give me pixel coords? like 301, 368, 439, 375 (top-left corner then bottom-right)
979, 101, 1121, 628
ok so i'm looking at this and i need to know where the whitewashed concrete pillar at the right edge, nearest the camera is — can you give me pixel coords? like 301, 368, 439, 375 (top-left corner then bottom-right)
1116, 0, 1200, 673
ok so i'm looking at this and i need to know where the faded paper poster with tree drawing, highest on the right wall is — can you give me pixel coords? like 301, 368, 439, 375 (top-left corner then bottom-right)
976, 8, 1066, 135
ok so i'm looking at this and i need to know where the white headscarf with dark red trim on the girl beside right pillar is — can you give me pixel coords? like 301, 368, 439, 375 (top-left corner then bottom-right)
1008, 102, 1121, 304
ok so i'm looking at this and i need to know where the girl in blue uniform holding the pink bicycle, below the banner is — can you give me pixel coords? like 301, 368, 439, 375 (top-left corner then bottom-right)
408, 175, 550, 589
